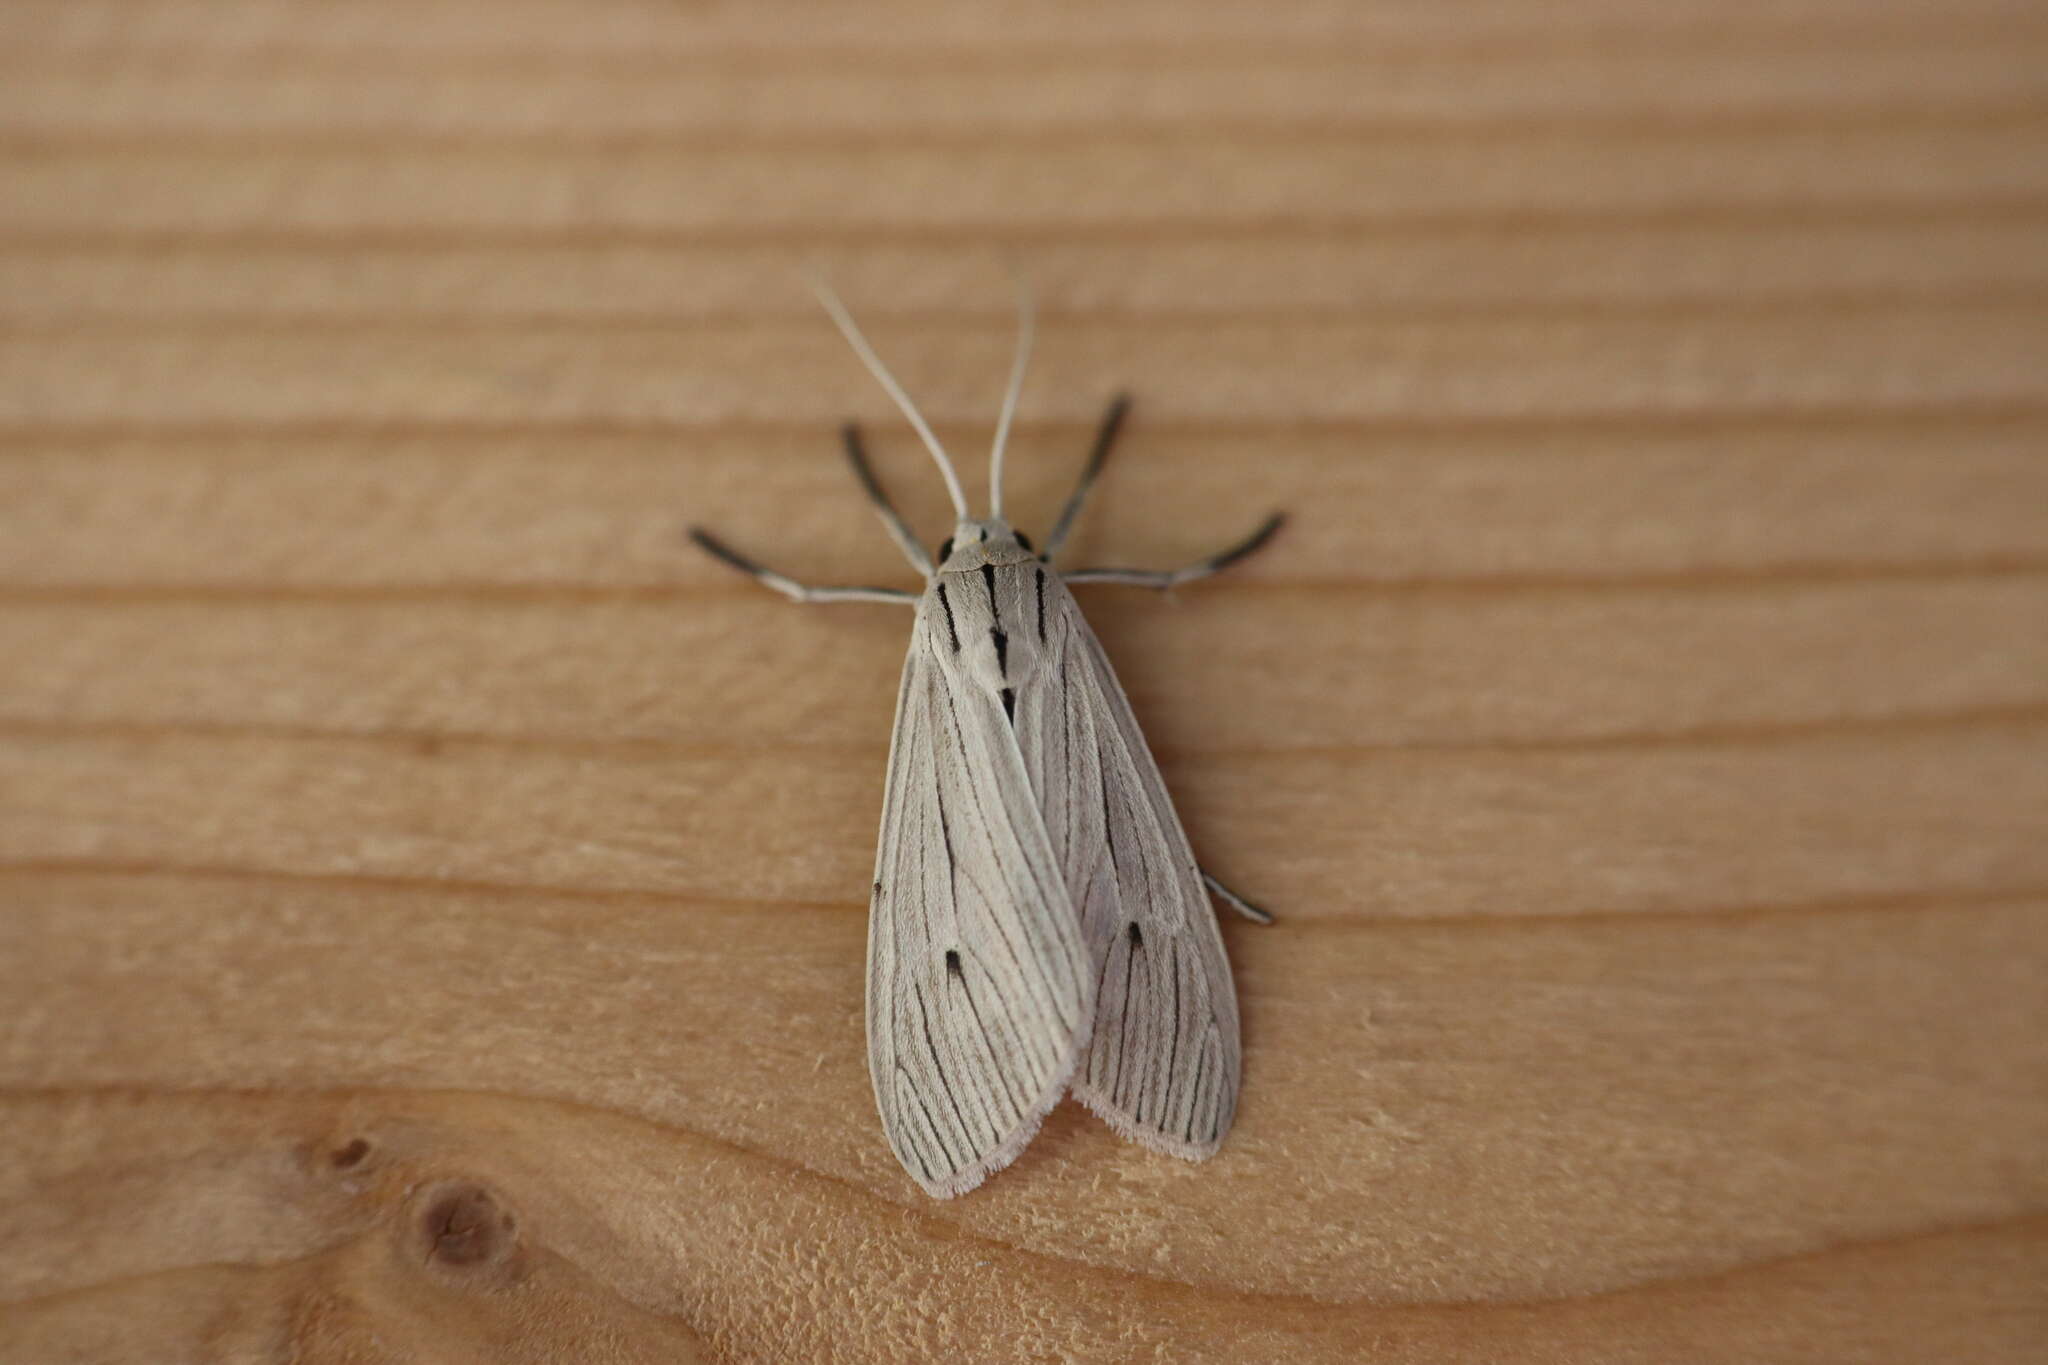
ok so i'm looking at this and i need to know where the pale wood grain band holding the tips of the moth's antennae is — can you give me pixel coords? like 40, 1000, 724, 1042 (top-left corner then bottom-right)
0, 211, 2048, 321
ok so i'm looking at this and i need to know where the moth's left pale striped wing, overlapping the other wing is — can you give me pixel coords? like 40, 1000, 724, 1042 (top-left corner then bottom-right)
868, 614, 1094, 1199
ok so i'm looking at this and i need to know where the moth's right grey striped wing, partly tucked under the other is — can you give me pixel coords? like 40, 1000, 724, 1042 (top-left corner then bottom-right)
1018, 575, 1241, 1160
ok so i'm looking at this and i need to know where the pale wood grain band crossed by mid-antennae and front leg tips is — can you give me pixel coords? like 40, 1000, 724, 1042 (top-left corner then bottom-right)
0, 303, 2048, 424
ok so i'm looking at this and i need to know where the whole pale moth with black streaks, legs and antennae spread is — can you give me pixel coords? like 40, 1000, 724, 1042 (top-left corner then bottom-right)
690, 284, 1280, 1199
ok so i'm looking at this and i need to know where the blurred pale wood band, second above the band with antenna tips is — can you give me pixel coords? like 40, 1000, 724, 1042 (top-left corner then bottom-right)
0, 41, 2048, 137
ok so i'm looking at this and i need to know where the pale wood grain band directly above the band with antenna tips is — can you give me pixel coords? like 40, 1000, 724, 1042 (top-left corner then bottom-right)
0, 119, 2048, 235
